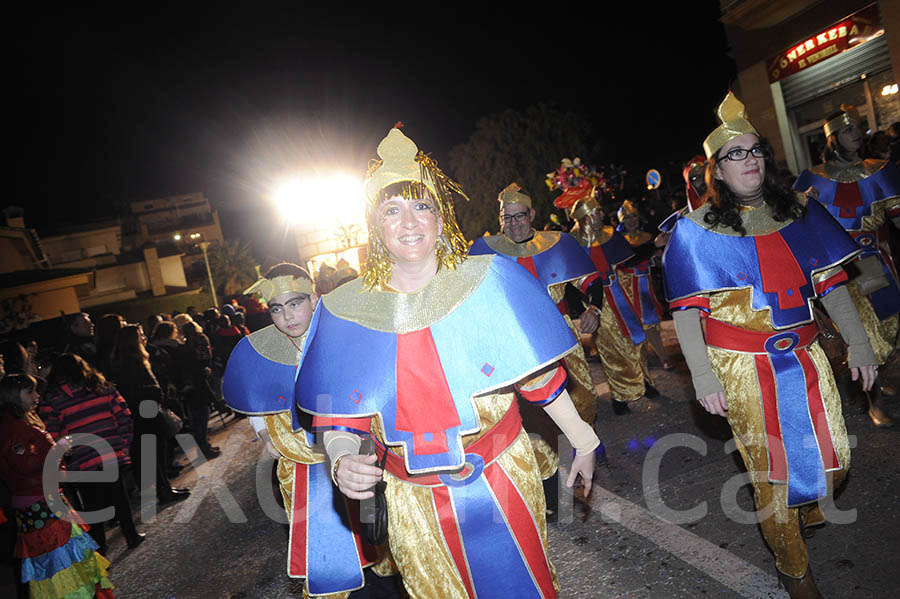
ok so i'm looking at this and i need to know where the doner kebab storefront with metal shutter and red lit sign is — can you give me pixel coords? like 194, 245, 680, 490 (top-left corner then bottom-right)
722, 0, 900, 174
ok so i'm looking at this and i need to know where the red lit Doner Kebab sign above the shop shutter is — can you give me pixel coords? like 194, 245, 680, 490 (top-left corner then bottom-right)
766, 4, 884, 83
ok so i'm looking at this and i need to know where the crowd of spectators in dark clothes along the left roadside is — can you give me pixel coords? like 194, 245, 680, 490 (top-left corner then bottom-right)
0, 292, 271, 592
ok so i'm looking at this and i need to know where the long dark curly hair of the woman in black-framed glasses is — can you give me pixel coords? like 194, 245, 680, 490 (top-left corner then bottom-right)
703, 138, 806, 235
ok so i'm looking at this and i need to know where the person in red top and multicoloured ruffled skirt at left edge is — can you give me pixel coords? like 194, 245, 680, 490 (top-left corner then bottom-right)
0, 374, 113, 599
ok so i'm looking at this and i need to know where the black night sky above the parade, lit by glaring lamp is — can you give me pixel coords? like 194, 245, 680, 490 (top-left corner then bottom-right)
10, 1, 735, 258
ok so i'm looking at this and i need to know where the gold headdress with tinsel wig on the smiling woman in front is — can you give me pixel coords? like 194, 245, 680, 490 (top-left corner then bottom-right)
361, 127, 469, 288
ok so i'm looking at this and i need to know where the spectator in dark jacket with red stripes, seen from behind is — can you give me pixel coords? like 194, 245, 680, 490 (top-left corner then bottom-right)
38, 354, 144, 553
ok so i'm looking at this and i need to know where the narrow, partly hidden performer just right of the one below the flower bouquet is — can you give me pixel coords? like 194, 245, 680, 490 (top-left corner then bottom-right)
616, 200, 672, 370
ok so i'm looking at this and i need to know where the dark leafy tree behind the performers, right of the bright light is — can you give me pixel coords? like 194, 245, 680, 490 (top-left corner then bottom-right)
449, 103, 596, 239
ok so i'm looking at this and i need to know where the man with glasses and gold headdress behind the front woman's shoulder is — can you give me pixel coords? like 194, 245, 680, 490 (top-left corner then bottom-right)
469, 183, 605, 512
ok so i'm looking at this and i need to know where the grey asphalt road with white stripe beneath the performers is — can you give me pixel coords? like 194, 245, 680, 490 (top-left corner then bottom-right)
102, 321, 900, 599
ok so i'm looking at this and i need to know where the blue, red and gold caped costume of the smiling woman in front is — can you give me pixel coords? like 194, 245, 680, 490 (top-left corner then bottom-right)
295, 254, 580, 598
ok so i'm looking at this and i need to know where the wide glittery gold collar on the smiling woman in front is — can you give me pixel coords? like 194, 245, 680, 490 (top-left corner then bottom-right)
320, 256, 493, 333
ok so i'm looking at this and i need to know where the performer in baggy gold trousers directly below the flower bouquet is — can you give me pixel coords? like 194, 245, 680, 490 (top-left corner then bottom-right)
554, 191, 651, 415
